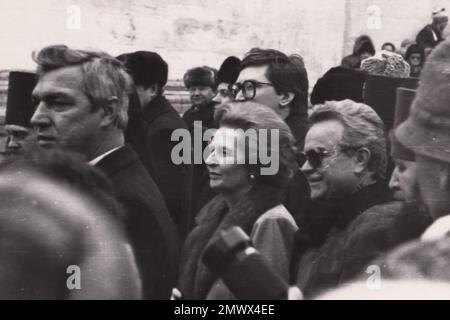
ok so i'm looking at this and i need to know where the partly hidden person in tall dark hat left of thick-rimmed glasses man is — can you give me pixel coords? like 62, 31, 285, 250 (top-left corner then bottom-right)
213, 56, 241, 109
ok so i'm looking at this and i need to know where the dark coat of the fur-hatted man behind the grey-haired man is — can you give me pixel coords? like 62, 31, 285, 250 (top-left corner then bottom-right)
143, 96, 194, 242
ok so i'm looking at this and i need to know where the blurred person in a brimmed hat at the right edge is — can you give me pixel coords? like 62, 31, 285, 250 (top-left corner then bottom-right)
395, 41, 450, 236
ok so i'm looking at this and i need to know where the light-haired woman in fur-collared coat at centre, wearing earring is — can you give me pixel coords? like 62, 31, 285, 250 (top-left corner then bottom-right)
174, 102, 298, 300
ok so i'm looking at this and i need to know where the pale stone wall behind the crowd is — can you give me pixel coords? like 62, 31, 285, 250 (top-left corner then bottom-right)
0, 0, 450, 117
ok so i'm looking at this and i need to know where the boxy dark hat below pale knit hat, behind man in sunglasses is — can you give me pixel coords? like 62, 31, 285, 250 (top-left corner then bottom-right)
364, 74, 418, 130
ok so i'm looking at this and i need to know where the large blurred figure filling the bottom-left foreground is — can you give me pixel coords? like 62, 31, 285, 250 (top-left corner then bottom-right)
0, 154, 142, 299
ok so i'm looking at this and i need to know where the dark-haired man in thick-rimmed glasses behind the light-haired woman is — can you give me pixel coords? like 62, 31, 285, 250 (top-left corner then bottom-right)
230, 48, 308, 149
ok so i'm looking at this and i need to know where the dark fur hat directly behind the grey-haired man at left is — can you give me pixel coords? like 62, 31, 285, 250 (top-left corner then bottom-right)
117, 51, 169, 88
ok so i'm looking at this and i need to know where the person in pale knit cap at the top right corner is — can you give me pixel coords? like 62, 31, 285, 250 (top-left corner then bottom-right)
416, 8, 448, 50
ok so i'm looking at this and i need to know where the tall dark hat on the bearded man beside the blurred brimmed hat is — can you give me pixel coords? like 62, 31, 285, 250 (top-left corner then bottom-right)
390, 88, 416, 161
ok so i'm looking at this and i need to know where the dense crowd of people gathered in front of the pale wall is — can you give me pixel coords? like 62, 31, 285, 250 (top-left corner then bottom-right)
0, 9, 450, 300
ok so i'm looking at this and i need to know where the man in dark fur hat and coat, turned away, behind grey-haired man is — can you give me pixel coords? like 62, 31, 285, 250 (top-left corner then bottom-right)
118, 51, 193, 241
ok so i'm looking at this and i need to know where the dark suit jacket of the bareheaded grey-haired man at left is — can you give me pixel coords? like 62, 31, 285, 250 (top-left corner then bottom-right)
96, 145, 178, 299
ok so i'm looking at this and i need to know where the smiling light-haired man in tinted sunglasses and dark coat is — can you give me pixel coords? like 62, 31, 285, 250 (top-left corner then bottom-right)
293, 100, 426, 298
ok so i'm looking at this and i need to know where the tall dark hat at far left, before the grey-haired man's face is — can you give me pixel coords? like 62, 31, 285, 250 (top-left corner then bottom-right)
5, 71, 37, 128
